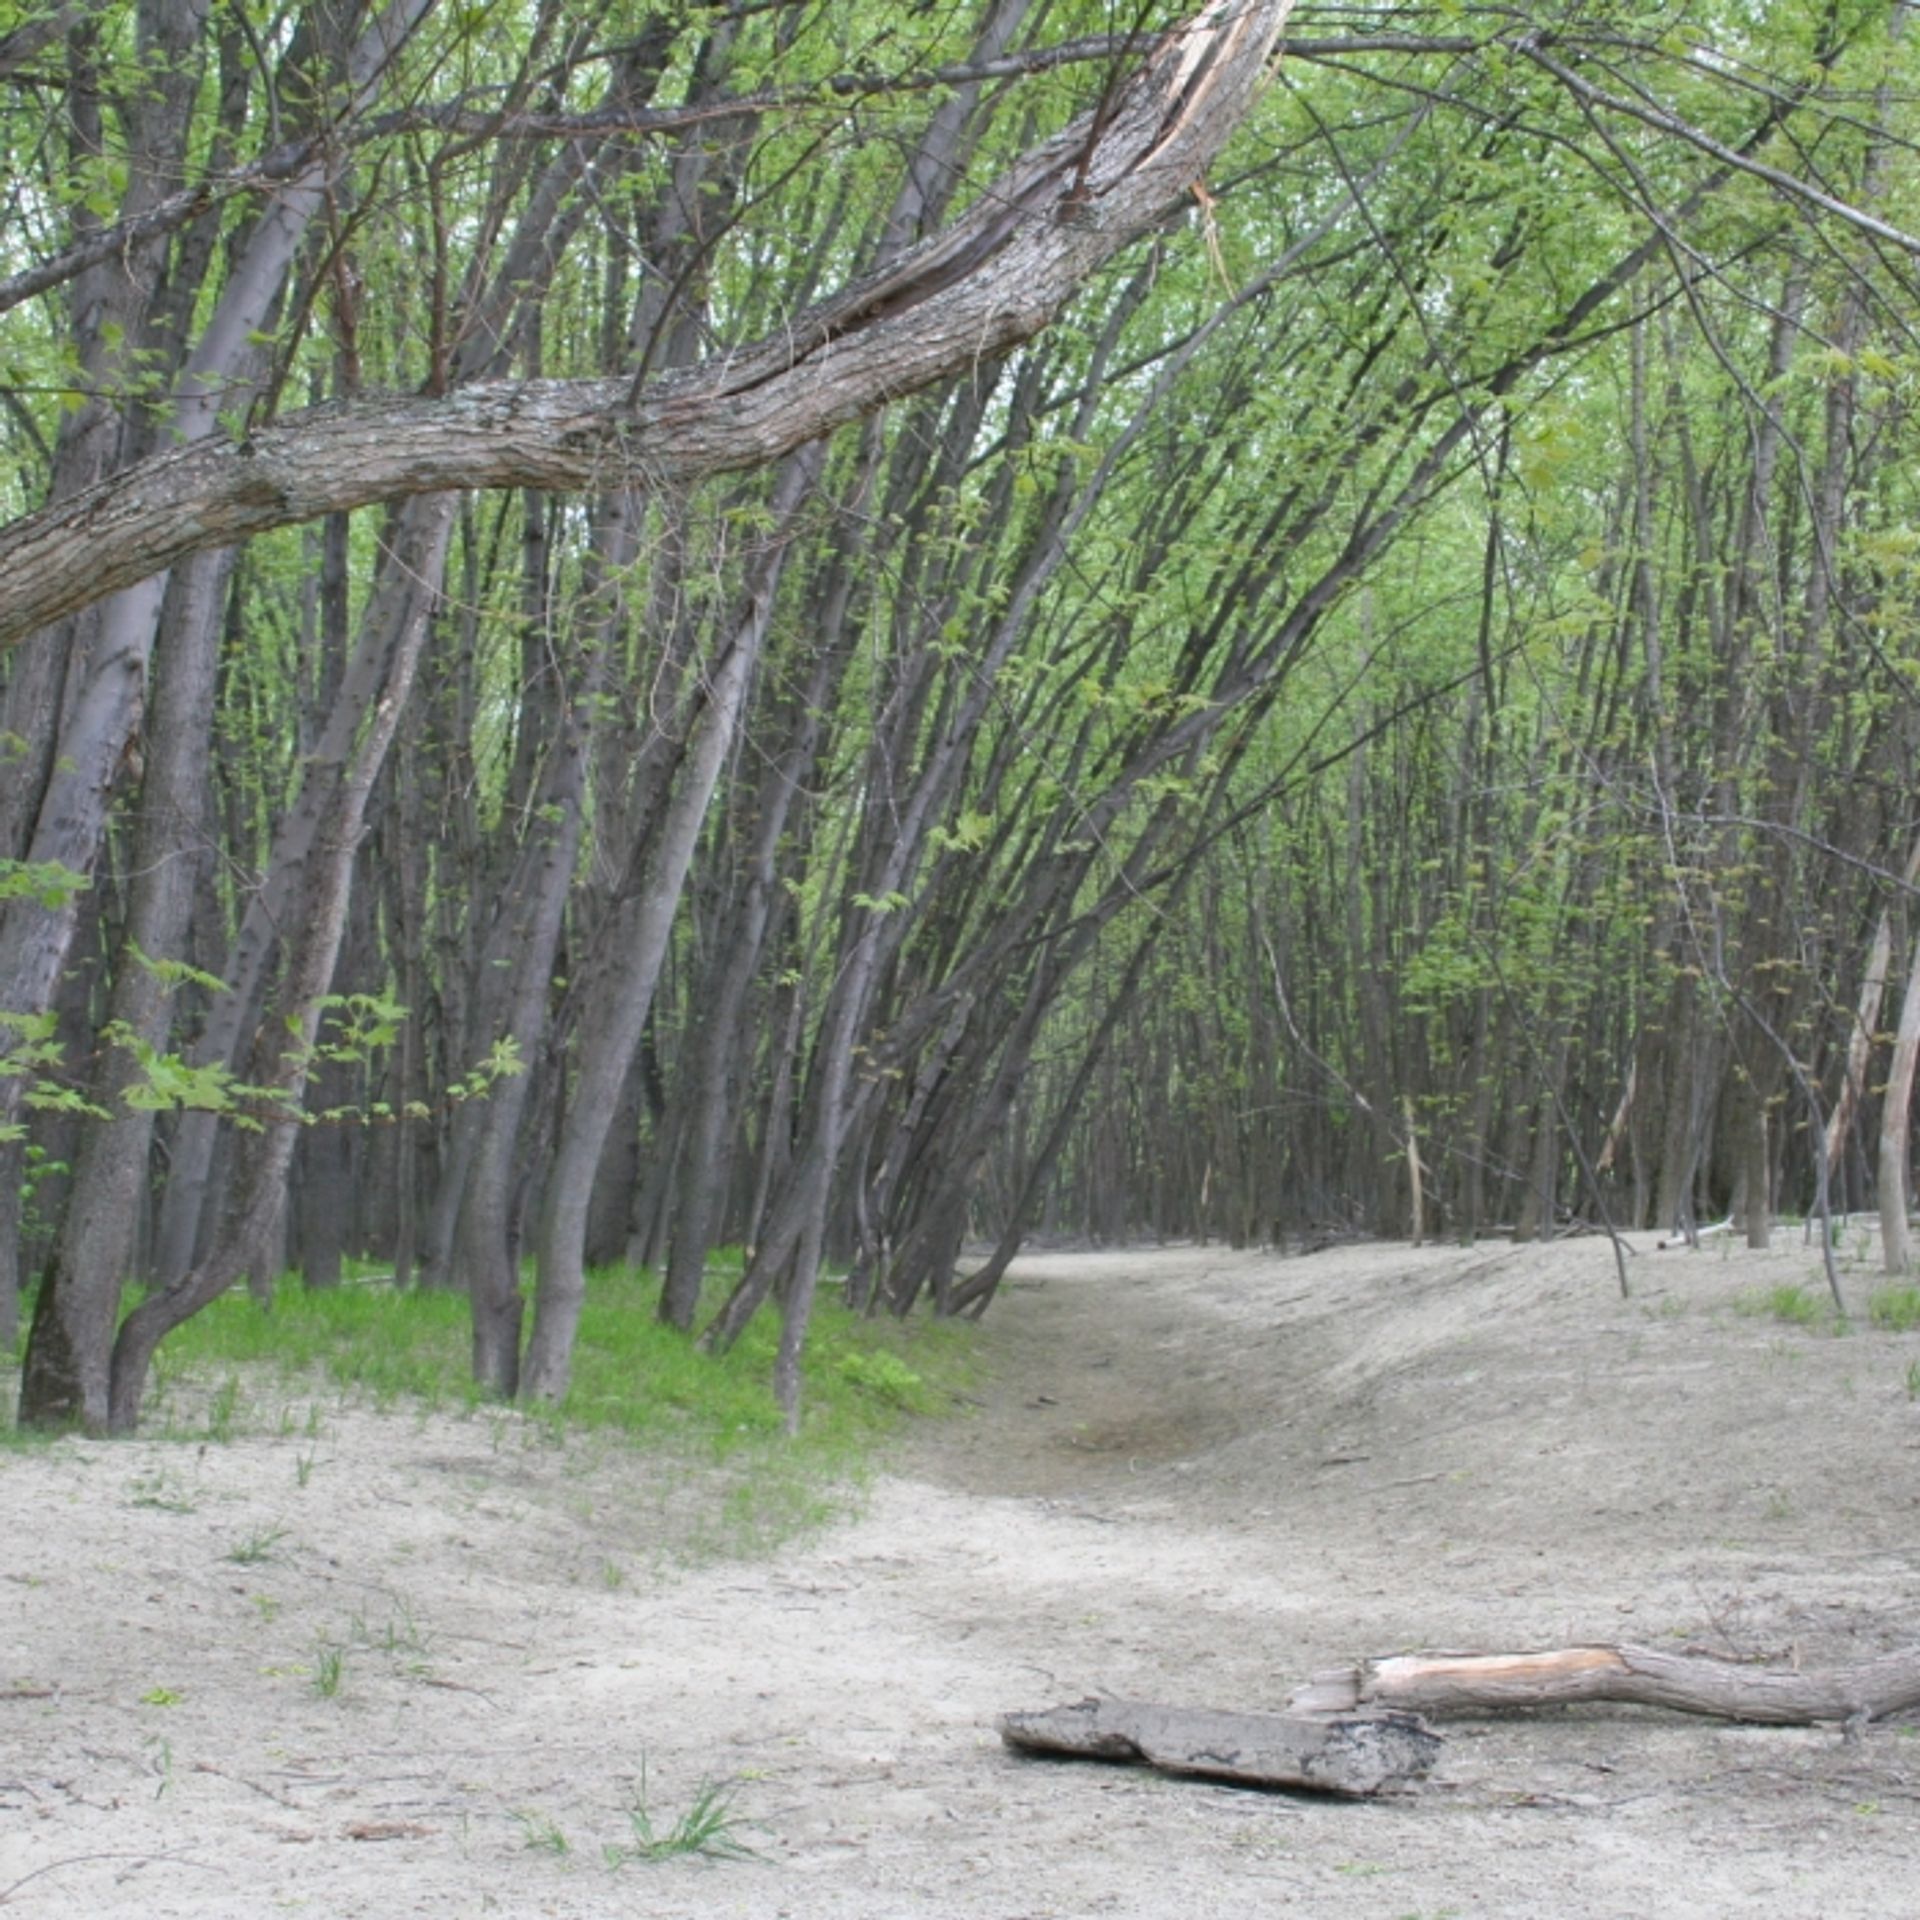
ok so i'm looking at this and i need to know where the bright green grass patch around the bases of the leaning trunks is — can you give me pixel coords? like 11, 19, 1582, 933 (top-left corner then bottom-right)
0, 1248, 973, 1565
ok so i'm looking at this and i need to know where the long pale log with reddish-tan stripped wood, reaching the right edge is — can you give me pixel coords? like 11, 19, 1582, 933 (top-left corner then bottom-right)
1286, 1645, 1920, 1726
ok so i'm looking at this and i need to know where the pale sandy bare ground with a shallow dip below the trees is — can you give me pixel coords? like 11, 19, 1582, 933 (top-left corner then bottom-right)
0, 1231, 1920, 1920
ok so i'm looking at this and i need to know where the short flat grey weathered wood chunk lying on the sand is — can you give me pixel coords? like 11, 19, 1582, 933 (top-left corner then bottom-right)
1000, 1699, 1440, 1797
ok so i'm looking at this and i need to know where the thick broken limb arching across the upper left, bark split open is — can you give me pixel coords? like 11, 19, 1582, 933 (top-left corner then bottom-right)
0, 0, 1292, 645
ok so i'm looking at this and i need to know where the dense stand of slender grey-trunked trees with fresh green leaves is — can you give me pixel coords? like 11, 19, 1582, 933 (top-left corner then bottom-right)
0, 0, 1920, 1432
